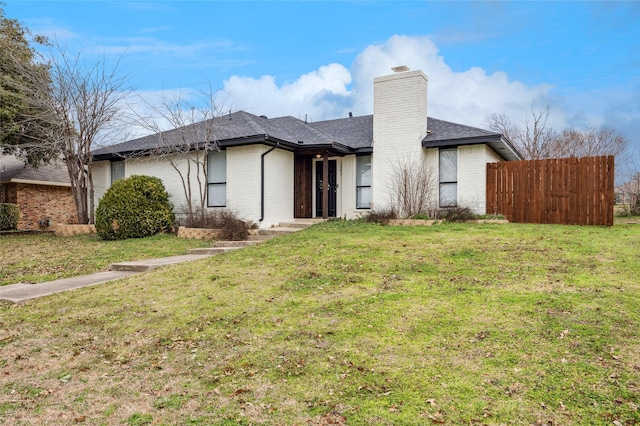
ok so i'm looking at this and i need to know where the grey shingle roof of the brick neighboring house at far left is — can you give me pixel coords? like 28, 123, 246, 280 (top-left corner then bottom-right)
0, 155, 71, 186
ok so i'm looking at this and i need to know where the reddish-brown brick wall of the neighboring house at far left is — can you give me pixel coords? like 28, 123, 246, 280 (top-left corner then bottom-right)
15, 183, 78, 229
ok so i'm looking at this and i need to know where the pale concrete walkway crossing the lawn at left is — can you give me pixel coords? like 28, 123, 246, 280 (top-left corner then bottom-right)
0, 254, 210, 303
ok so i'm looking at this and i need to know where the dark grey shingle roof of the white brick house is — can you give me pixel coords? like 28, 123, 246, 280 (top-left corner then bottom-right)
93, 111, 519, 159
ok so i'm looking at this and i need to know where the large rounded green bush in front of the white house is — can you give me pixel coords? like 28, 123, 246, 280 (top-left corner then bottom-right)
96, 176, 175, 240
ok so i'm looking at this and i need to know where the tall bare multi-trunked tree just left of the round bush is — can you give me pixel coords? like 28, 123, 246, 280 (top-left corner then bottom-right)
43, 46, 131, 223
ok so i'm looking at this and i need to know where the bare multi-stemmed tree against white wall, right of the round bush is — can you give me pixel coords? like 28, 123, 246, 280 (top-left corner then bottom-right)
132, 85, 224, 226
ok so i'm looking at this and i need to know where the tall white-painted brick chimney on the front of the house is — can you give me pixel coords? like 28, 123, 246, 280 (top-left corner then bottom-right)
371, 71, 427, 208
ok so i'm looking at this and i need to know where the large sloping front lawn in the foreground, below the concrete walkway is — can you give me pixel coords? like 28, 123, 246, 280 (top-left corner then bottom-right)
0, 222, 640, 425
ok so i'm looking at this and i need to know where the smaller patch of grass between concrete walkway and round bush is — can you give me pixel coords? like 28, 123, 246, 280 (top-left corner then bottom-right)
0, 234, 211, 286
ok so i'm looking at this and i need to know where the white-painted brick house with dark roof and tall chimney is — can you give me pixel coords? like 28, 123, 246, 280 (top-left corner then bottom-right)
92, 71, 522, 227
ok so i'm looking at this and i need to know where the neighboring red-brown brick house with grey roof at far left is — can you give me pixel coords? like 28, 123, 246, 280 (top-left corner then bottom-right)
0, 155, 78, 230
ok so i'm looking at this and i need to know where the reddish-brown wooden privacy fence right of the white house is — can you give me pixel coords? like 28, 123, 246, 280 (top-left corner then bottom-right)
487, 156, 614, 226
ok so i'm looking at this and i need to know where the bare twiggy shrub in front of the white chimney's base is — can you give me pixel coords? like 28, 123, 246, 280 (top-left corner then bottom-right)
389, 158, 438, 217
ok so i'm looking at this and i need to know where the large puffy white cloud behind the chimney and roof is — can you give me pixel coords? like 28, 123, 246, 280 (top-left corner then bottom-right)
224, 36, 562, 127
